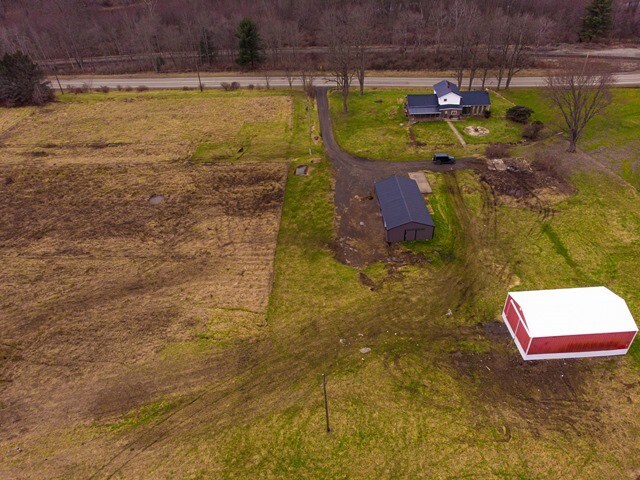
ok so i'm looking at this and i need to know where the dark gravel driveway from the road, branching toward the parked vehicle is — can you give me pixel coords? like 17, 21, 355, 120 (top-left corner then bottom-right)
317, 87, 477, 267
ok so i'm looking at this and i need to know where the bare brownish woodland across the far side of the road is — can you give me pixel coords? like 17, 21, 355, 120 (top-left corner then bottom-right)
0, 0, 640, 76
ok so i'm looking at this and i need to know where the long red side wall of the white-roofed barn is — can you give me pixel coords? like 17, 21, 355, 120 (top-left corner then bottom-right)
527, 332, 636, 355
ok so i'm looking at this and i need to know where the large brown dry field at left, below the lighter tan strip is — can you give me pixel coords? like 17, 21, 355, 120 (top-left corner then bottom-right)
0, 163, 287, 446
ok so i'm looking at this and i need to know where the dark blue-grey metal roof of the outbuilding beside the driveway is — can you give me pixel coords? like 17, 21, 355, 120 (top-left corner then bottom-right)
375, 175, 435, 230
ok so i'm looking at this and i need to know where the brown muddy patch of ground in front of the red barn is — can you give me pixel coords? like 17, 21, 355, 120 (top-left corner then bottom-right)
449, 336, 606, 437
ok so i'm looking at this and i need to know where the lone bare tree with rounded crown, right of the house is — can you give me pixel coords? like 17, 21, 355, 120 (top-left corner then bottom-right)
546, 59, 613, 152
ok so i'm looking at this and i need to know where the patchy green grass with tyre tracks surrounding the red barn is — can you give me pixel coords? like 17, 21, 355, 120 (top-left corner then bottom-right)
199, 148, 640, 479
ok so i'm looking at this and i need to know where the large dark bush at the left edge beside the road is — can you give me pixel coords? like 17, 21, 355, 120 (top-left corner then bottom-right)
0, 51, 54, 107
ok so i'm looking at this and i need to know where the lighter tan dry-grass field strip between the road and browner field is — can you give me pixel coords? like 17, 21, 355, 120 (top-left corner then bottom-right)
0, 95, 292, 165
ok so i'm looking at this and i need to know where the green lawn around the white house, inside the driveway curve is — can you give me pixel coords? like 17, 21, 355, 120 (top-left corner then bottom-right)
329, 89, 522, 161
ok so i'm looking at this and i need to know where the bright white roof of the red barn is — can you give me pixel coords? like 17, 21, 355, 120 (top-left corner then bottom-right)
509, 287, 638, 337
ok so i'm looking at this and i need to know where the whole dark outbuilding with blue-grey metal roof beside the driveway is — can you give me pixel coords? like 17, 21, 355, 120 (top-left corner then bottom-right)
375, 175, 435, 242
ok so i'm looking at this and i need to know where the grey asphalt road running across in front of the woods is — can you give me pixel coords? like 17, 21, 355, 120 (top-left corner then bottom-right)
50, 72, 640, 89
